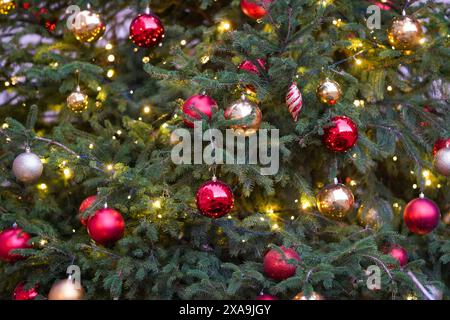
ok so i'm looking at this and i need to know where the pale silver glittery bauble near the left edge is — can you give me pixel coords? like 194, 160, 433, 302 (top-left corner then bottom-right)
13, 150, 44, 183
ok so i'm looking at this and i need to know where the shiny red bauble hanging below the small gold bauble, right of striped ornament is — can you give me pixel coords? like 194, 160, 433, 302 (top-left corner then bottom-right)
323, 116, 358, 152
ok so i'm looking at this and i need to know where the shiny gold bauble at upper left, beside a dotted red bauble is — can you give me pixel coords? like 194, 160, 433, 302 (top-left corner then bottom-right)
70, 10, 106, 42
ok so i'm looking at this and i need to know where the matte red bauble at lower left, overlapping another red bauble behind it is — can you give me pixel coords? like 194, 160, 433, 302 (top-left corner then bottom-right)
87, 208, 125, 246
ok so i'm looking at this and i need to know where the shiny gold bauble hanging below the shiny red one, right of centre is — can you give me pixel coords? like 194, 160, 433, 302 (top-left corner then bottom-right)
317, 183, 355, 220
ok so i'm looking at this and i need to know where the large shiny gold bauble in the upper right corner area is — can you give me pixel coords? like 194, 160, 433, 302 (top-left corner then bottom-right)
388, 16, 423, 50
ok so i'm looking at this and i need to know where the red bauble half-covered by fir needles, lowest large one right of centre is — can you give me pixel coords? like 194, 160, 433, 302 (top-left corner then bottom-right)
264, 247, 300, 280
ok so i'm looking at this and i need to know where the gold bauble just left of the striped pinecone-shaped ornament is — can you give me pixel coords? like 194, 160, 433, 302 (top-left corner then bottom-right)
225, 95, 262, 136
